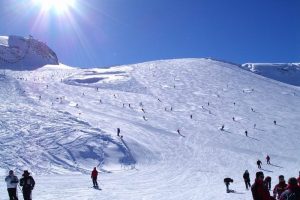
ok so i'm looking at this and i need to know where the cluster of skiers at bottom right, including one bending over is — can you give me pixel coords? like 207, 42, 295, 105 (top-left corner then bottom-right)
224, 170, 300, 200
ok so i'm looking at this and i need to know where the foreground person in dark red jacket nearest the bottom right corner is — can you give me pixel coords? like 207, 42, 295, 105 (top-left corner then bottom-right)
280, 177, 300, 200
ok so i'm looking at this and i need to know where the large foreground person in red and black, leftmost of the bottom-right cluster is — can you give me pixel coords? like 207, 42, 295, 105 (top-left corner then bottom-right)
251, 172, 272, 200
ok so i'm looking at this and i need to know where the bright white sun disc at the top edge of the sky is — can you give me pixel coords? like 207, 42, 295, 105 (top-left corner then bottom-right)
34, 0, 74, 12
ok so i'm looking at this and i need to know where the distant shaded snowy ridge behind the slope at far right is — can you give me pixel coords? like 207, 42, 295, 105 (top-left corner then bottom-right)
242, 63, 300, 86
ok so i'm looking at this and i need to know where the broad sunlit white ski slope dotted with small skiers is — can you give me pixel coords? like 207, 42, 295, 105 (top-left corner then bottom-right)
0, 59, 300, 200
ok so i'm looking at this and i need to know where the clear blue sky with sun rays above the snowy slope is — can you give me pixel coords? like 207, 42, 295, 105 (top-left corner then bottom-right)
0, 0, 300, 68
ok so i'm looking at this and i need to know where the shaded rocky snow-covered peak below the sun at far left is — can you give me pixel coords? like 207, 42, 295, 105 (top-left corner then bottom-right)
0, 35, 59, 70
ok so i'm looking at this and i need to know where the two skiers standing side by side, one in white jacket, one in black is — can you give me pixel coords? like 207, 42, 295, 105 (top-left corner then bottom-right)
5, 170, 35, 200
